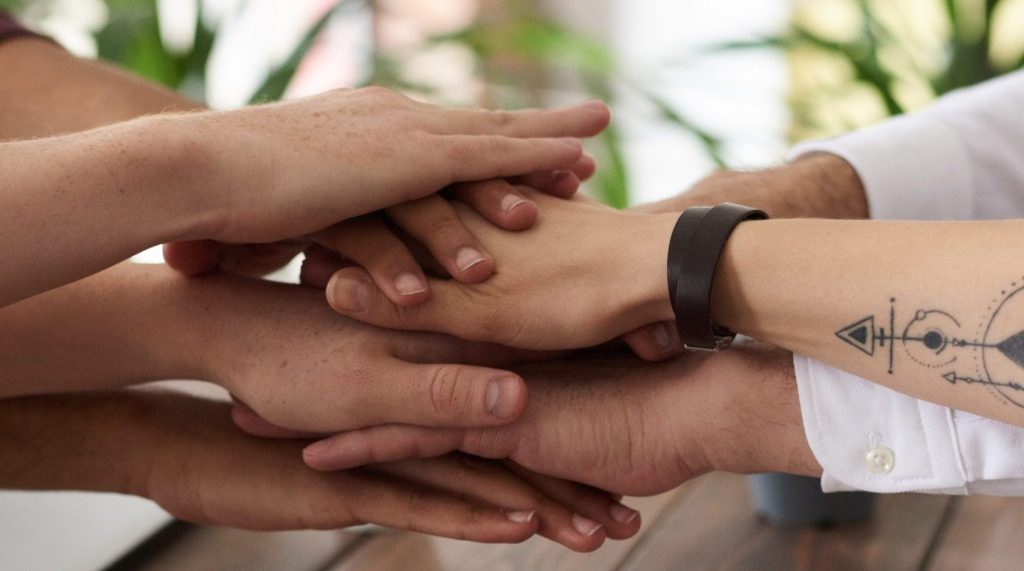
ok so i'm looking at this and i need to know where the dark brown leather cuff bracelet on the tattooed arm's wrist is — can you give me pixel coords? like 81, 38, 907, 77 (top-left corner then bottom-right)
669, 203, 768, 351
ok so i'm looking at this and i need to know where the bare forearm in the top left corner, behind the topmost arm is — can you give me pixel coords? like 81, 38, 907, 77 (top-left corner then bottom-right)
0, 37, 200, 140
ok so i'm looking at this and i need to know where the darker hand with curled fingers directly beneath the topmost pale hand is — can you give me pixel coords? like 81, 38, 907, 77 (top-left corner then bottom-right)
164, 155, 596, 305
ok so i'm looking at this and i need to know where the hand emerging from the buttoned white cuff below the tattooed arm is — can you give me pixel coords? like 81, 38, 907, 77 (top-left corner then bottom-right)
292, 344, 820, 495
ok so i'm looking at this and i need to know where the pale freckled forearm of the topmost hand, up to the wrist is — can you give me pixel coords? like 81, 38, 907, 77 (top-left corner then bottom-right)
0, 118, 216, 307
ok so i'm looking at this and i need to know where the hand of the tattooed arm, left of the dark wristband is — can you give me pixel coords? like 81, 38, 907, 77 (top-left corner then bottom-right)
319, 191, 677, 349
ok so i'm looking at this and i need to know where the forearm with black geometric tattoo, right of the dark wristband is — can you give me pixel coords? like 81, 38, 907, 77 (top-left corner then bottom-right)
713, 220, 1024, 424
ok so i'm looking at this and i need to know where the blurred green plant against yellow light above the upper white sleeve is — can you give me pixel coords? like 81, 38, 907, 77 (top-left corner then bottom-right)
714, 0, 1024, 138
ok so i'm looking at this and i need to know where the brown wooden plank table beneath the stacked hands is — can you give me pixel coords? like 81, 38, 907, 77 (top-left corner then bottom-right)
114, 474, 1024, 571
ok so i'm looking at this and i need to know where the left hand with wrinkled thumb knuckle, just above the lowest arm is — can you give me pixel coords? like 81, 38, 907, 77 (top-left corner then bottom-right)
190, 275, 569, 432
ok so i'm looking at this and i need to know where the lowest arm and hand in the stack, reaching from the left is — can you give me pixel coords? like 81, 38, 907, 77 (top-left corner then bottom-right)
0, 391, 640, 551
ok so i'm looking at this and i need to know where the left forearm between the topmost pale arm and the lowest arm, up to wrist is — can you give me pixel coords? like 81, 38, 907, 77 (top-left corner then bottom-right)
0, 264, 212, 397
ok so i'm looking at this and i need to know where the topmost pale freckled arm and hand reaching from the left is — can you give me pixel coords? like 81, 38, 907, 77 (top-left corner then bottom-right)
0, 40, 607, 305
